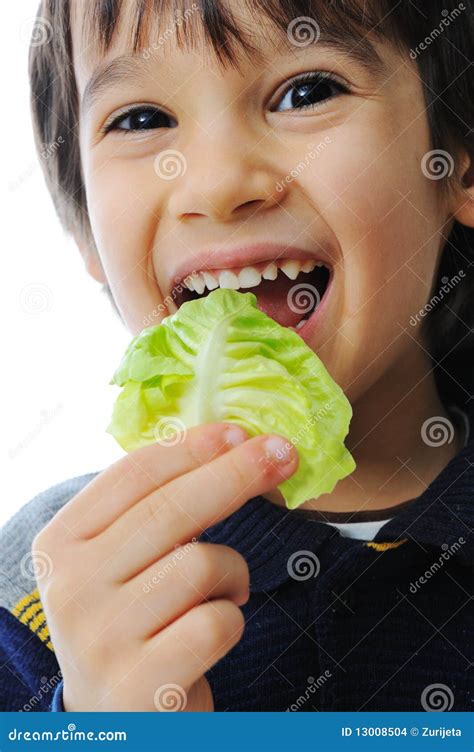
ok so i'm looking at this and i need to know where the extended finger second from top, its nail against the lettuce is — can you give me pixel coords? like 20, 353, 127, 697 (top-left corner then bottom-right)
97, 436, 298, 581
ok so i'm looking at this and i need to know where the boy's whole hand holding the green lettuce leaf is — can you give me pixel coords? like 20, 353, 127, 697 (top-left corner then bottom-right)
32, 424, 298, 711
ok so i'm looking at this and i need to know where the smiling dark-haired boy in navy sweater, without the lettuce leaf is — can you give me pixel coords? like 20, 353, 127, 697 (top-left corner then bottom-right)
0, 0, 474, 711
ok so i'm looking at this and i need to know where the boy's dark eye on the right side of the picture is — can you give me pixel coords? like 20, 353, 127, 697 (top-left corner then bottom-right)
273, 72, 349, 112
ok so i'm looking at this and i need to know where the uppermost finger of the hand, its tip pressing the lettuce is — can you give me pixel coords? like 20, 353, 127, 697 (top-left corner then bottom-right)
51, 423, 248, 538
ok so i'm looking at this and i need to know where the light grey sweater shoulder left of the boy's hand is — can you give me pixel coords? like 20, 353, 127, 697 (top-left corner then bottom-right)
0, 473, 97, 615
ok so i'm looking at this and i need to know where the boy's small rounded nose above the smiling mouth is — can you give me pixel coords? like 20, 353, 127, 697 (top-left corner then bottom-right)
168, 133, 282, 222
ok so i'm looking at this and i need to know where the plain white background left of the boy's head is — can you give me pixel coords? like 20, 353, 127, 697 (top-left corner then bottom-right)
0, 0, 130, 525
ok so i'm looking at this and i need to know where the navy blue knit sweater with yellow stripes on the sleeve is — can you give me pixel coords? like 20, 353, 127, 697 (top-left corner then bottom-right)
0, 424, 474, 711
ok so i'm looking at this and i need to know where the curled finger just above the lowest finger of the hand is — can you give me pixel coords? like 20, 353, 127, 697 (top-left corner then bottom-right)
120, 542, 249, 639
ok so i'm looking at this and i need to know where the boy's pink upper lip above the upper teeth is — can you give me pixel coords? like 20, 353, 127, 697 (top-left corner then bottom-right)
169, 243, 333, 292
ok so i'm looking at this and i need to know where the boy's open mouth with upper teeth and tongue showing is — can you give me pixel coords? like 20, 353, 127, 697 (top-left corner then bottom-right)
173, 259, 331, 329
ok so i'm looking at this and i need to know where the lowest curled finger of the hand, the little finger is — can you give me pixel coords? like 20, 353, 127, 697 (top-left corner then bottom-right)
141, 599, 244, 689
